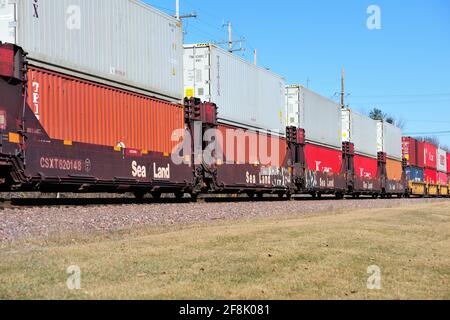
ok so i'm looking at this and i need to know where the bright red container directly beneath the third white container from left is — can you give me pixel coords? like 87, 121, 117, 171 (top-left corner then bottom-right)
305, 144, 342, 174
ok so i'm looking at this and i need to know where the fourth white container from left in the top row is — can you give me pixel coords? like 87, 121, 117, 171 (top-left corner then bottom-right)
342, 109, 378, 158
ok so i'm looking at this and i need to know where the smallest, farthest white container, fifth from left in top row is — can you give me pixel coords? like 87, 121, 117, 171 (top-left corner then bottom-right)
377, 121, 402, 161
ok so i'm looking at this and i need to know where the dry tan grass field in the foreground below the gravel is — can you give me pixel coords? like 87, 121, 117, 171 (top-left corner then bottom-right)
0, 202, 450, 299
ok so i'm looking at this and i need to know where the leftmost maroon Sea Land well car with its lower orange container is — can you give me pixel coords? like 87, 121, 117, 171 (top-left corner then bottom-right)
0, 44, 192, 197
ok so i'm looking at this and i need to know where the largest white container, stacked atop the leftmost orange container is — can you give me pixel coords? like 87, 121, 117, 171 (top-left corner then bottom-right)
0, 0, 183, 100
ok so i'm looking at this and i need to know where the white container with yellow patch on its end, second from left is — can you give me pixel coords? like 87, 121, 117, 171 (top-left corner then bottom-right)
184, 44, 286, 135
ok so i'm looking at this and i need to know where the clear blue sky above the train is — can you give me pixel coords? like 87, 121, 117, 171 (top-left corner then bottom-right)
146, 0, 450, 146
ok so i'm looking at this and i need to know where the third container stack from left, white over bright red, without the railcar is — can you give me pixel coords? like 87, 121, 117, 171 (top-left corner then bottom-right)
286, 85, 342, 174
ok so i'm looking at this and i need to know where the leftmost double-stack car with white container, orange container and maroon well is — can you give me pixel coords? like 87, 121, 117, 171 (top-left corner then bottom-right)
0, 0, 192, 197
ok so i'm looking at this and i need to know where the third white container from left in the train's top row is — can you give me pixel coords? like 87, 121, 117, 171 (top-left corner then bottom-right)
286, 85, 342, 149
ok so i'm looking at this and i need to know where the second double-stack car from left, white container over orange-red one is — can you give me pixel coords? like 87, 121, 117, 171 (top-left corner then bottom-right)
184, 44, 290, 195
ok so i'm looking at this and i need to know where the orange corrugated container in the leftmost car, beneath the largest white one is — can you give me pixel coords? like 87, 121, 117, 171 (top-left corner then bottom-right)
27, 67, 184, 154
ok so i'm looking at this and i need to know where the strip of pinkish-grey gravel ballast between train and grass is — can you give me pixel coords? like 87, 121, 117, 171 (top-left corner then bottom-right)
0, 199, 445, 244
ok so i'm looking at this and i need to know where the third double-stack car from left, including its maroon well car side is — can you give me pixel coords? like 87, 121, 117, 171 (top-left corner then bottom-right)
286, 85, 346, 195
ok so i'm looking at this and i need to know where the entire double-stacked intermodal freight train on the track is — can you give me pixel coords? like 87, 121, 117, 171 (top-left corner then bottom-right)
0, 0, 450, 199
